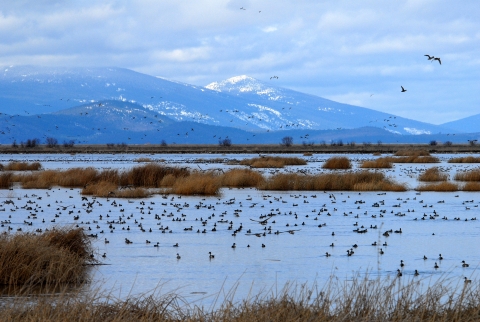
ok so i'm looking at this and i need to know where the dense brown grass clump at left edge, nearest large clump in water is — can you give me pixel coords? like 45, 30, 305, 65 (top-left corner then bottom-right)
0, 228, 95, 285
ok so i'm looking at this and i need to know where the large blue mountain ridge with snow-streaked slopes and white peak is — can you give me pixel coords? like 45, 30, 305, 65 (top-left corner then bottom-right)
0, 66, 474, 143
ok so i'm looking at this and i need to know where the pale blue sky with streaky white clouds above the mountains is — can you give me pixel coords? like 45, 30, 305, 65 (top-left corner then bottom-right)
0, 0, 480, 124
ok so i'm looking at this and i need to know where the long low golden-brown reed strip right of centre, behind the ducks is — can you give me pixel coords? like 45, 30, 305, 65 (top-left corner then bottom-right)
259, 171, 407, 191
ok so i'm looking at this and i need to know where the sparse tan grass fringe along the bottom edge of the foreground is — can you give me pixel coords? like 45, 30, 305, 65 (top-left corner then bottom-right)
0, 277, 480, 322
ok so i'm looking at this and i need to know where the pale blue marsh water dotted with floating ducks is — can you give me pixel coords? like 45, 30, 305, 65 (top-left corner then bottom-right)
0, 154, 480, 304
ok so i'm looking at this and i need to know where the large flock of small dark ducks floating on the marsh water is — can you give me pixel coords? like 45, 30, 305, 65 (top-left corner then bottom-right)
0, 155, 479, 286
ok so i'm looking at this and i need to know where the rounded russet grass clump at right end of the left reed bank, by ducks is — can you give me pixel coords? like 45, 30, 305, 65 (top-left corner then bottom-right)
171, 172, 221, 196
